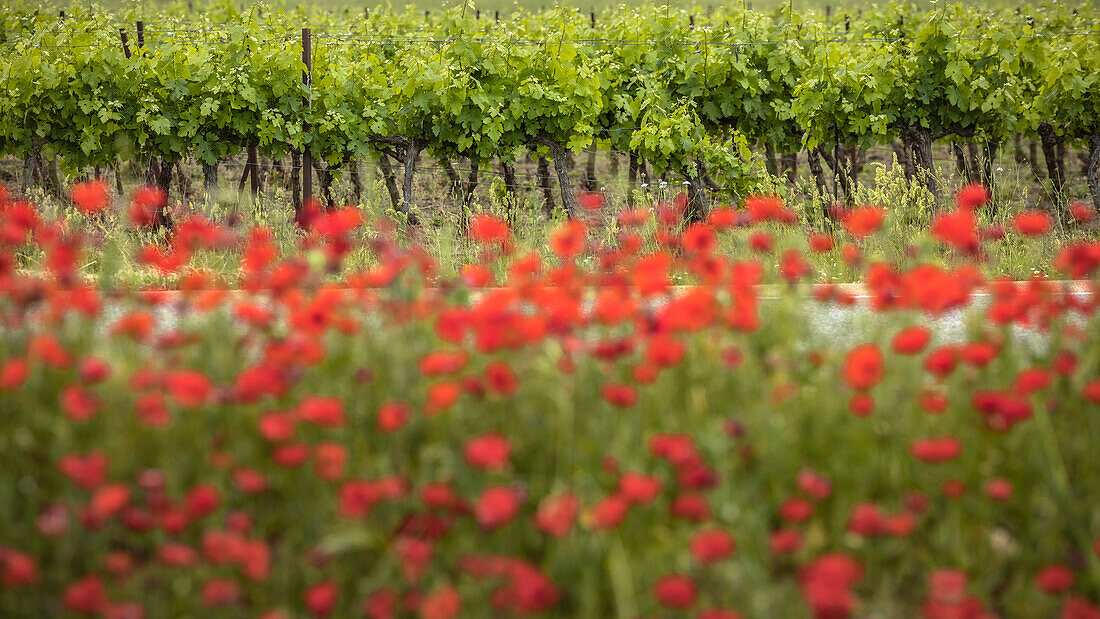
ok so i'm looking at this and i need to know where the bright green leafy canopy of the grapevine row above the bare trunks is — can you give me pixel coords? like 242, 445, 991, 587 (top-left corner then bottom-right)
0, 3, 1100, 186
